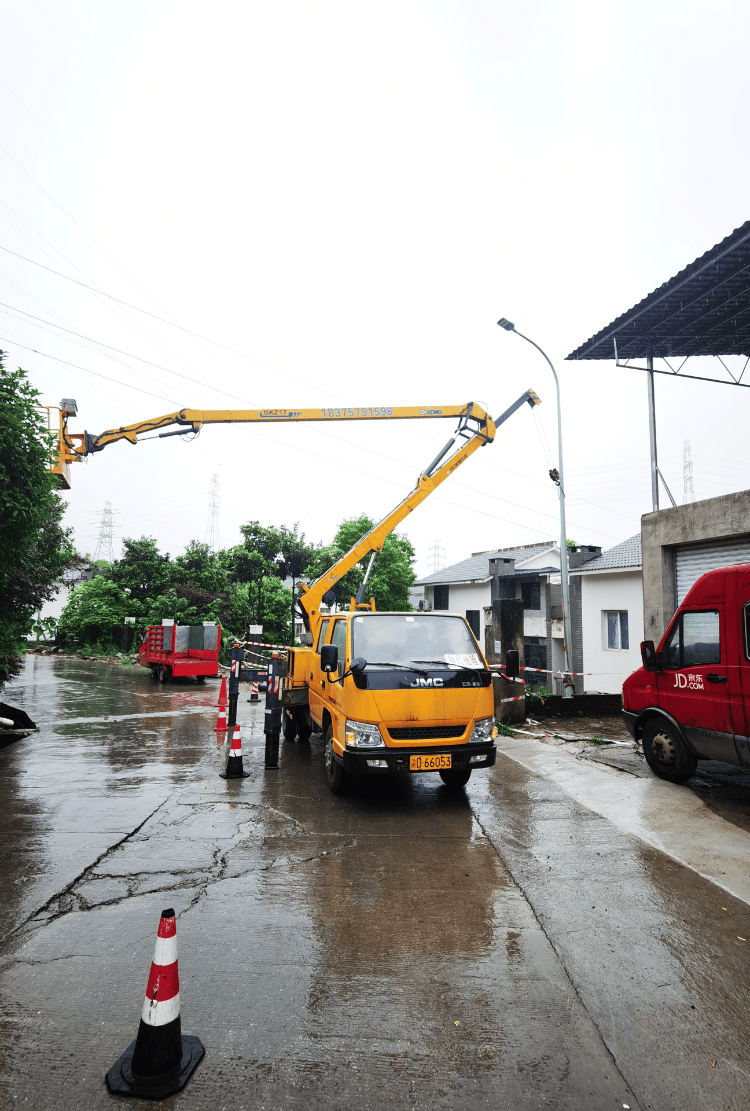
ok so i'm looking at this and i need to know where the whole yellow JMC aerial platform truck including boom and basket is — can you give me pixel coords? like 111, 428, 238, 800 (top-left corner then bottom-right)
53, 390, 540, 794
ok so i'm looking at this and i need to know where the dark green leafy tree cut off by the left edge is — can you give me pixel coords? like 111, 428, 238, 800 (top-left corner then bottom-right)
0, 351, 77, 681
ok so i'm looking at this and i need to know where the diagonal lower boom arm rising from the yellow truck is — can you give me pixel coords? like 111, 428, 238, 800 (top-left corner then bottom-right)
298, 390, 540, 632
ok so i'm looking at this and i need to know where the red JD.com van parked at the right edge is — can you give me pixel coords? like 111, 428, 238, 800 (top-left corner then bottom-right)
622, 563, 750, 783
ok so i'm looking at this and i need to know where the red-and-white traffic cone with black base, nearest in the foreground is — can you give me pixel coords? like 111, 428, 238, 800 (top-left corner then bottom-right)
107, 909, 206, 1100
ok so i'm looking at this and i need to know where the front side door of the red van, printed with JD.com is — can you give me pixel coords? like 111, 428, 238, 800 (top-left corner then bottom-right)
656, 603, 739, 764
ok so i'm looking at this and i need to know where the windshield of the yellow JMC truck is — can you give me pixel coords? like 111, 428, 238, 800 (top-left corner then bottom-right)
351, 613, 484, 668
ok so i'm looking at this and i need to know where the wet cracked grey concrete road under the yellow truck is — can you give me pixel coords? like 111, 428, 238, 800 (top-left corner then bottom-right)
0, 657, 750, 1111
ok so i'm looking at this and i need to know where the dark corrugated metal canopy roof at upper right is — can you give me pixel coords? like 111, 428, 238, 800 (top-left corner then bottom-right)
568, 220, 750, 360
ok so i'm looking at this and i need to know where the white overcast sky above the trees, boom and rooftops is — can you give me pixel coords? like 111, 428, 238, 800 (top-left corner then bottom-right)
0, 0, 750, 573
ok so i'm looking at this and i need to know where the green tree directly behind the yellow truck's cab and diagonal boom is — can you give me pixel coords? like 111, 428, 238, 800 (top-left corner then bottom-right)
309, 514, 417, 610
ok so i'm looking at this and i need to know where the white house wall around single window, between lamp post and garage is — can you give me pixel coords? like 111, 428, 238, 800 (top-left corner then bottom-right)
581, 570, 643, 694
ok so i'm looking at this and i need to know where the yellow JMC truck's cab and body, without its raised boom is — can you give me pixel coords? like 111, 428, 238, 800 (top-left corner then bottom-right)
282, 610, 498, 794
